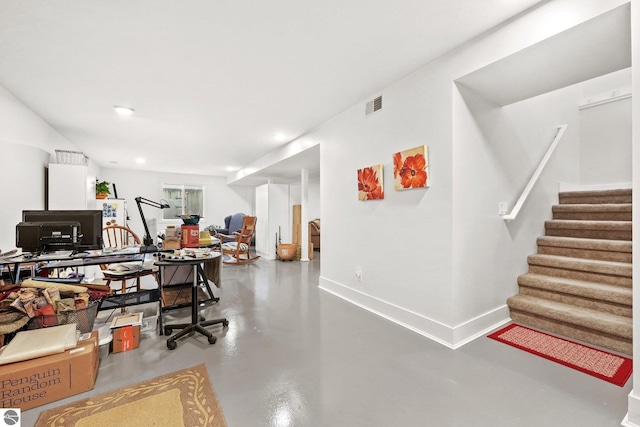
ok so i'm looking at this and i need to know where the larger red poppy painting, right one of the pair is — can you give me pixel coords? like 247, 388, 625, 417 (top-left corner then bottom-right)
393, 145, 429, 190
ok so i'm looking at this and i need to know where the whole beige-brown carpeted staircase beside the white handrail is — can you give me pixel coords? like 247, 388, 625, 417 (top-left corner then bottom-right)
507, 189, 632, 355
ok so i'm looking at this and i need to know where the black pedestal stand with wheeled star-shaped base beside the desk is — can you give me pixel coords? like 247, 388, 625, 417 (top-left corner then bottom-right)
156, 254, 229, 350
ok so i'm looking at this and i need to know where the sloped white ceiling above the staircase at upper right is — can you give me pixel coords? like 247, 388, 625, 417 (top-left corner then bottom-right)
457, 4, 631, 105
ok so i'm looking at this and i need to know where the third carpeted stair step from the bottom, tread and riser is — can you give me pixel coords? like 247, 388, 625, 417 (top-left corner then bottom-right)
527, 254, 632, 287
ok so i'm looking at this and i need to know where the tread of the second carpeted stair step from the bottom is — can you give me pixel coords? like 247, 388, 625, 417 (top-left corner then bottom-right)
518, 273, 633, 306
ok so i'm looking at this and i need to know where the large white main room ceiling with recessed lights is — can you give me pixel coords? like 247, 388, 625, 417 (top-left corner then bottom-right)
0, 0, 544, 185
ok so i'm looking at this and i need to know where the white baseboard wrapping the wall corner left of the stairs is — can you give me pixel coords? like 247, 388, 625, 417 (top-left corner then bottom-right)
318, 276, 511, 350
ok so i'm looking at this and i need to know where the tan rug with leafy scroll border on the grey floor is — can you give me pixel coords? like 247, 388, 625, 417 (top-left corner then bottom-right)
36, 365, 227, 427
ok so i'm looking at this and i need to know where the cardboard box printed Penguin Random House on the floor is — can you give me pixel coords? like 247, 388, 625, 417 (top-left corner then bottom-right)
0, 332, 100, 411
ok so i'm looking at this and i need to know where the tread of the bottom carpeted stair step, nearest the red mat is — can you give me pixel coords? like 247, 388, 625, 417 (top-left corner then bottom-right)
507, 294, 633, 339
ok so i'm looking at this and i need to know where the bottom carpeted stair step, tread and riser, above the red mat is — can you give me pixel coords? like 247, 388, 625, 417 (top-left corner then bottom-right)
507, 294, 633, 354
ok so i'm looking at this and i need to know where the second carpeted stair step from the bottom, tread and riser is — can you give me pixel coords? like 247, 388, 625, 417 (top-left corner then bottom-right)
518, 273, 633, 317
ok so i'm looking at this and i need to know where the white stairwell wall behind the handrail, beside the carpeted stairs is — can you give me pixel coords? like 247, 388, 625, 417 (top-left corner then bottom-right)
453, 73, 631, 336
